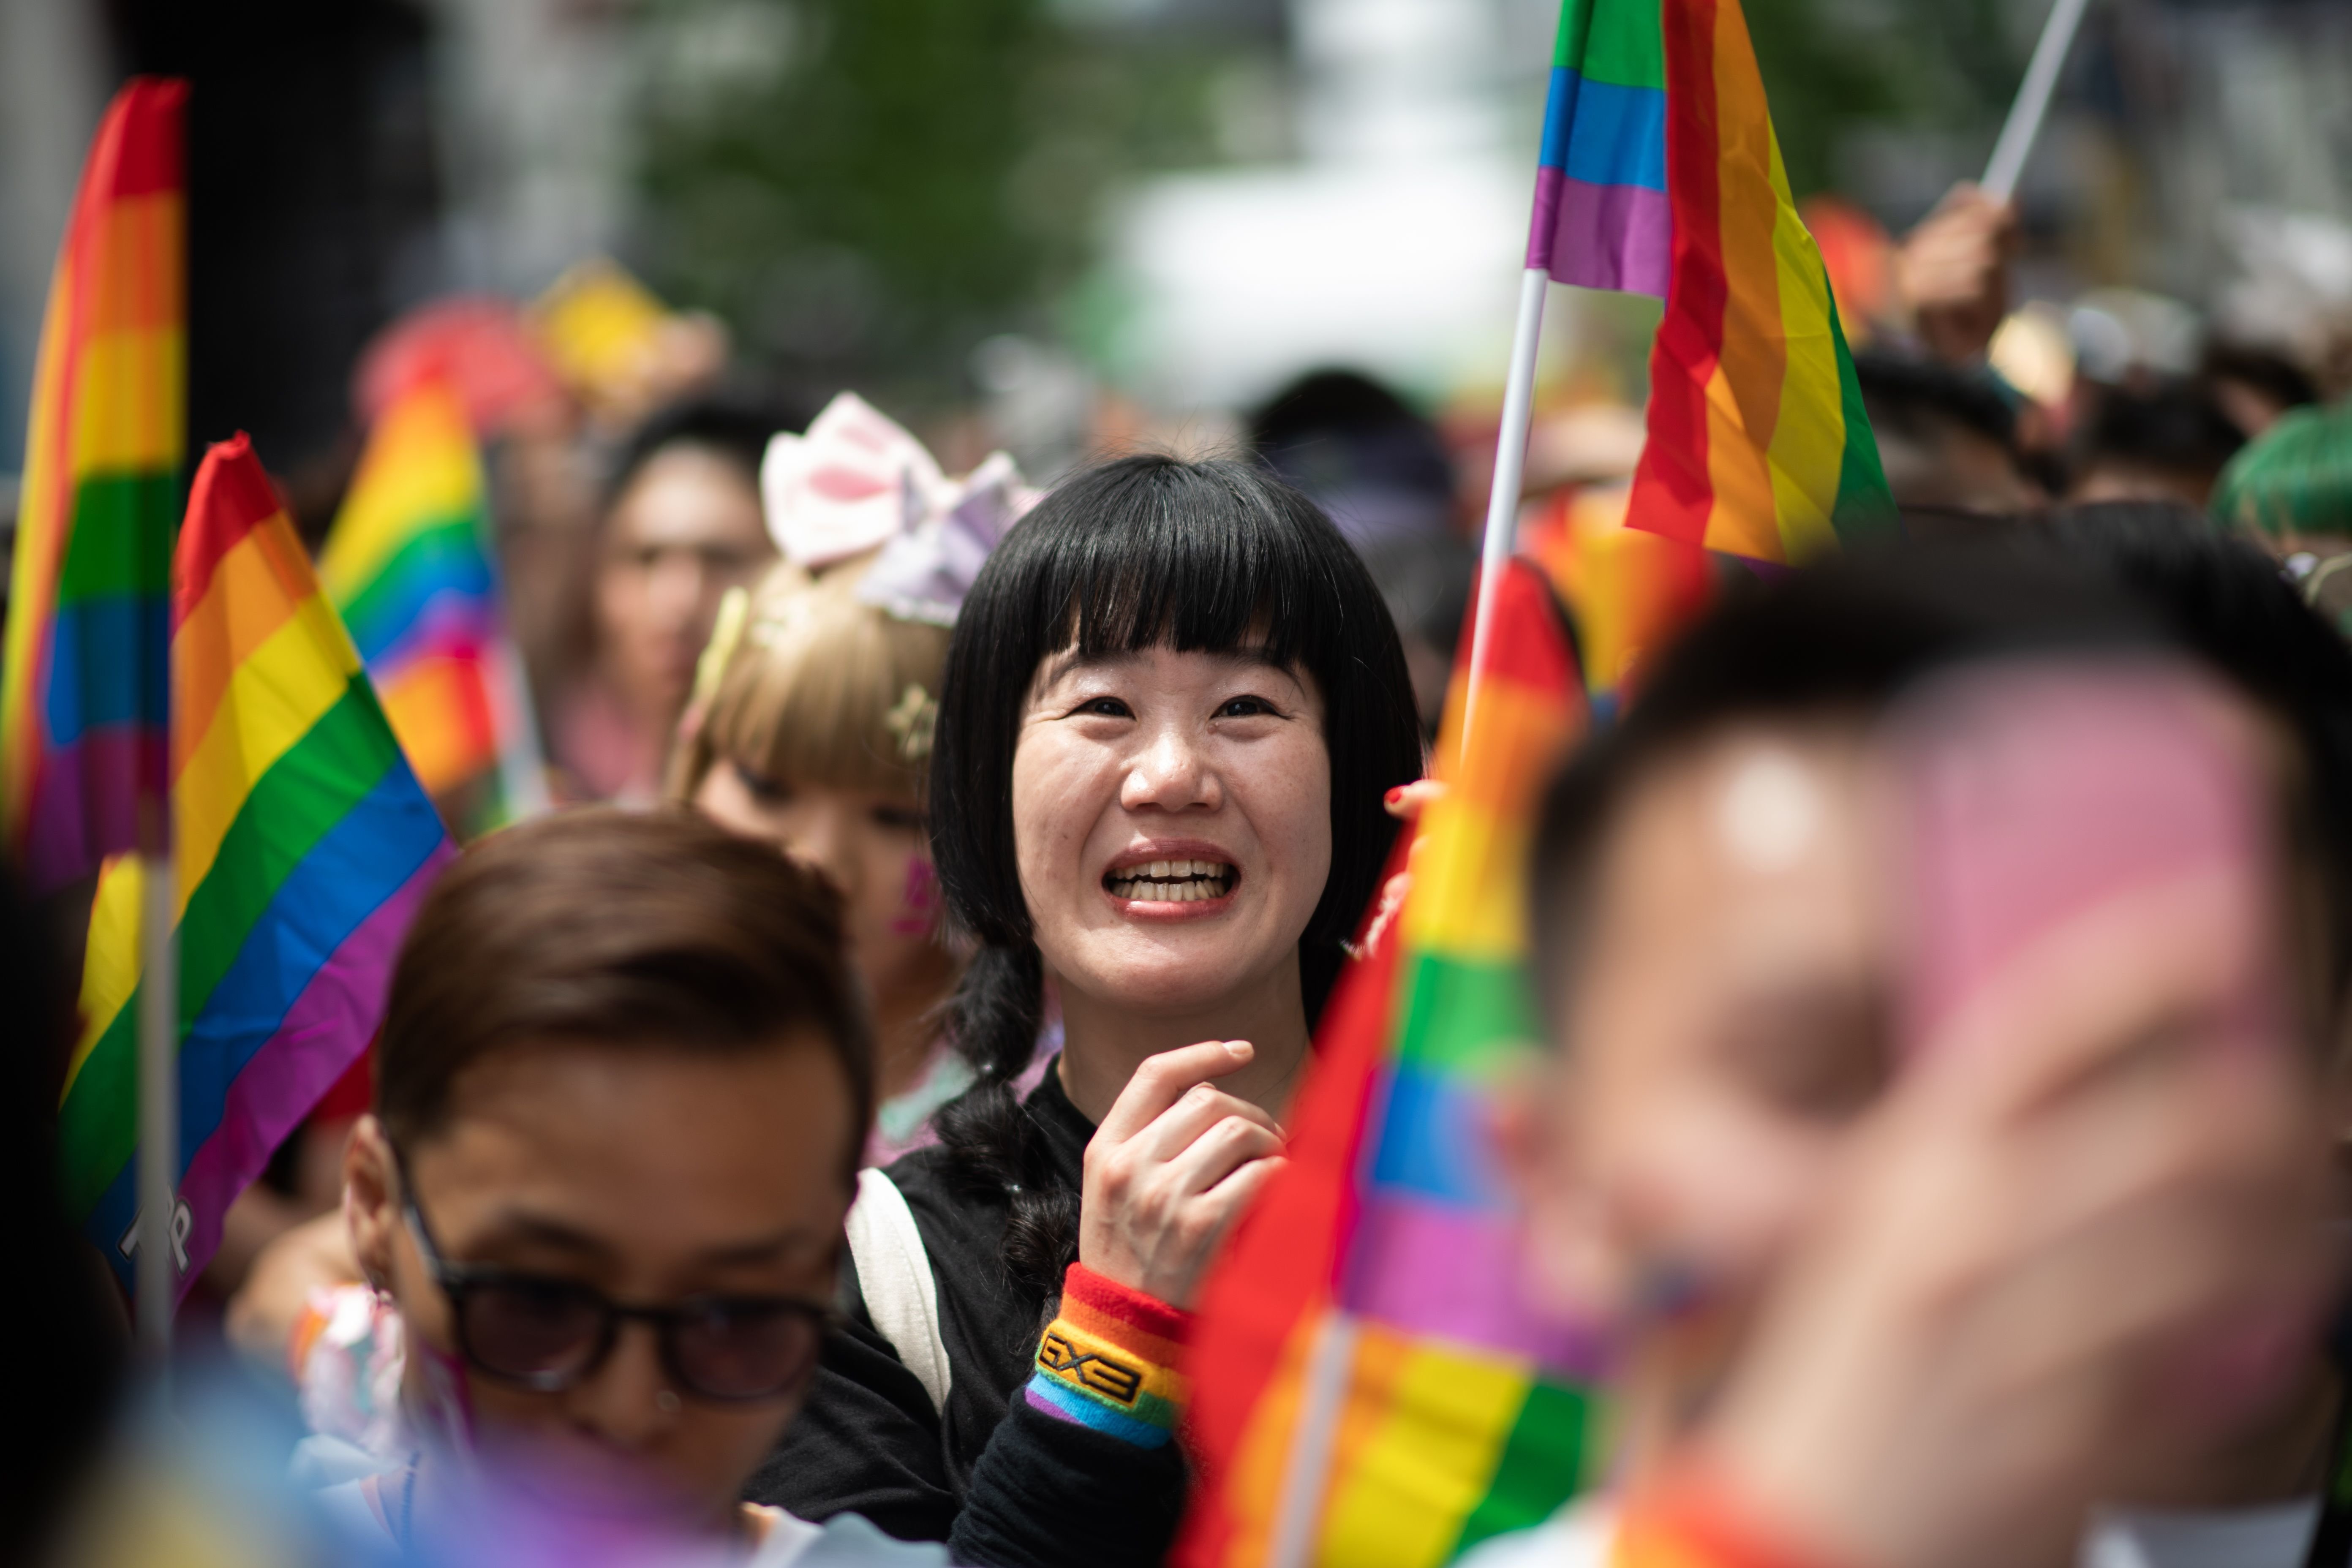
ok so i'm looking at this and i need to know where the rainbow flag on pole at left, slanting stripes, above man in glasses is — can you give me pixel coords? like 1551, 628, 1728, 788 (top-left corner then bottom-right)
59, 435, 452, 1290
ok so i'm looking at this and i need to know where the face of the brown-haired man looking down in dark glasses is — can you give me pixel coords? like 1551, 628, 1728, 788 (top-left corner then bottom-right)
351, 1039, 854, 1533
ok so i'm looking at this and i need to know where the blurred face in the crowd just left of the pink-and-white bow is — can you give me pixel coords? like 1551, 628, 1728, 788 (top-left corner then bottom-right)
595, 442, 776, 729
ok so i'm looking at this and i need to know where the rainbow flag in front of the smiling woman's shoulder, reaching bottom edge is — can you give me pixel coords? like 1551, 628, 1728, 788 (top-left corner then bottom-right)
1179, 562, 1595, 1568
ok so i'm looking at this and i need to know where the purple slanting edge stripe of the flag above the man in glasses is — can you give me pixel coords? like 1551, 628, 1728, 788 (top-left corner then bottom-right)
179, 846, 456, 1295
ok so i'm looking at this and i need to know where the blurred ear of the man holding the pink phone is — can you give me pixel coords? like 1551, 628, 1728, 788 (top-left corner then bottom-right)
1489, 1058, 1632, 1326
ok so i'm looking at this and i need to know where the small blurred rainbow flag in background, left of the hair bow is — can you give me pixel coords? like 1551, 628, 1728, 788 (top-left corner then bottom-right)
318, 381, 543, 828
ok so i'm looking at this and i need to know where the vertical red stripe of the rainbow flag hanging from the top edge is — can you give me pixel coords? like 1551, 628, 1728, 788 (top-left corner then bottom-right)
1628, 0, 1731, 545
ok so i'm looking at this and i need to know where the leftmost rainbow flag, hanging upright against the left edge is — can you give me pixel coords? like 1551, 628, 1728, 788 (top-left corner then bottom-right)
0, 78, 188, 891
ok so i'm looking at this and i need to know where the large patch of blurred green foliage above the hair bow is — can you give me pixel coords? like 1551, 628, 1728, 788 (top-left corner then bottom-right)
637, 0, 1230, 404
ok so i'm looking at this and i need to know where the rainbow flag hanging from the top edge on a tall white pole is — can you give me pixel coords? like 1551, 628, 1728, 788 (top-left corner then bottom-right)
1527, 0, 1896, 562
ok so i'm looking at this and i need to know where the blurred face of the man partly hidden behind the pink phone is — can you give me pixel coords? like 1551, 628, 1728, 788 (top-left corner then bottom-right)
1510, 724, 2326, 1500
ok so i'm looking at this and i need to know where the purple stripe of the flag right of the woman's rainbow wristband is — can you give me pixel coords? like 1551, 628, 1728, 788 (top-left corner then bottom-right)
1341, 1192, 1604, 1375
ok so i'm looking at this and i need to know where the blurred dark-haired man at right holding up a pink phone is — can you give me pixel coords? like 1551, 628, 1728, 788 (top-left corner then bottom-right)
1473, 548, 2352, 1568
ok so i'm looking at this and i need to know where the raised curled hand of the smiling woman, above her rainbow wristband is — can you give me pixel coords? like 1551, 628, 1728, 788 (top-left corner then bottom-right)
1077, 1039, 1282, 1309
